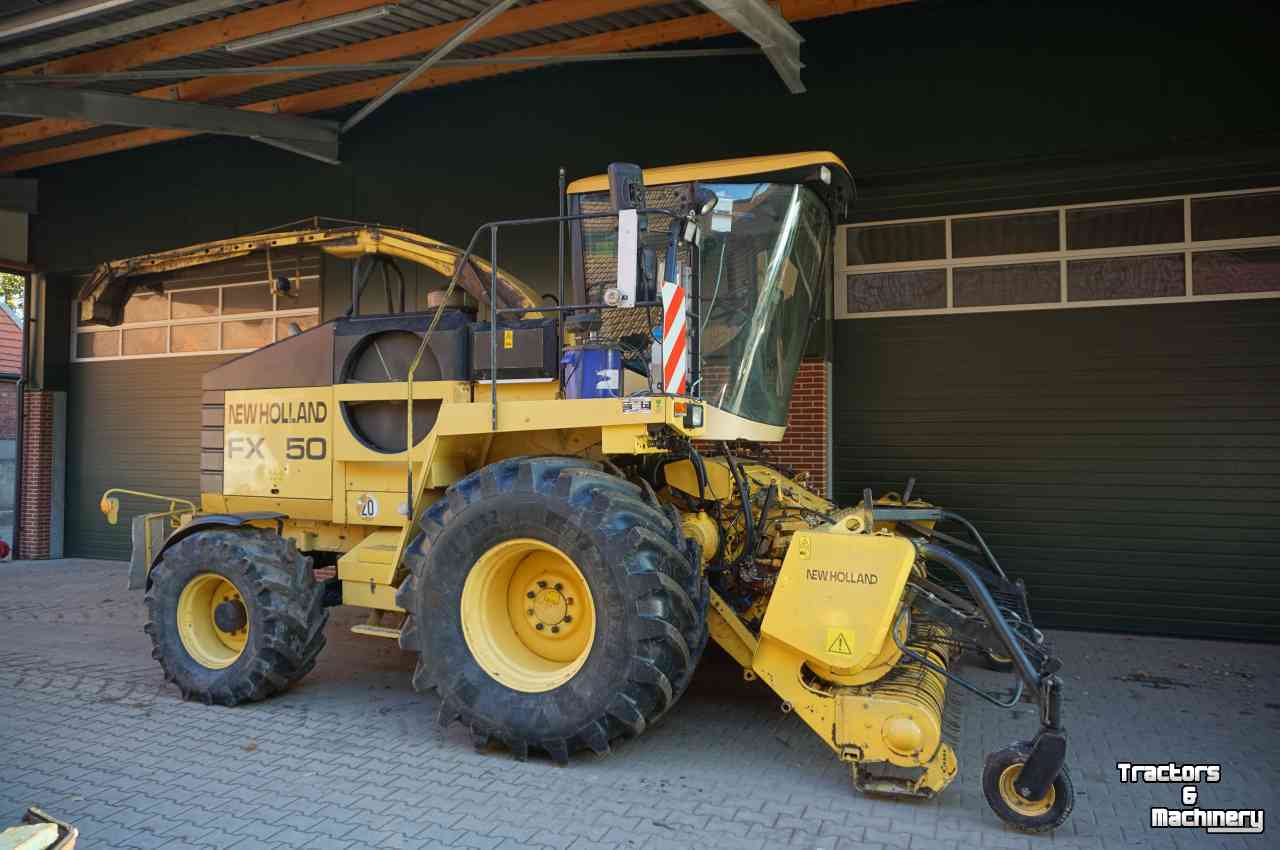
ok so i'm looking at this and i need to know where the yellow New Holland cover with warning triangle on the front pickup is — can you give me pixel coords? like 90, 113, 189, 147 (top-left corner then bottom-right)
760, 525, 915, 673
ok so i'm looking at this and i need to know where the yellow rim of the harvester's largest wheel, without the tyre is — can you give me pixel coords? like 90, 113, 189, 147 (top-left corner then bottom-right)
462, 538, 595, 694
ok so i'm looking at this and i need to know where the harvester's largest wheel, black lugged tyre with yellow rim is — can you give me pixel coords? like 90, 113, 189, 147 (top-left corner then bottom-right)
397, 457, 709, 763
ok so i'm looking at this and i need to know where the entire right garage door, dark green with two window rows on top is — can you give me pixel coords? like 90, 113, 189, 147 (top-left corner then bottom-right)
832, 188, 1280, 640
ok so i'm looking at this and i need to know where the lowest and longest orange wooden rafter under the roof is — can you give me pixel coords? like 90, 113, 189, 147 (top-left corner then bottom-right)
0, 0, 909, 173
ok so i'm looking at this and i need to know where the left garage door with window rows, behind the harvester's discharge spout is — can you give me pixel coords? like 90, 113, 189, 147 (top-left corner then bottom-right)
67, 251, 320, 558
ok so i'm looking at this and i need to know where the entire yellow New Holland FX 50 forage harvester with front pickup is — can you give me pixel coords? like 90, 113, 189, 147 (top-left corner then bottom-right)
102, 152, 1073, 831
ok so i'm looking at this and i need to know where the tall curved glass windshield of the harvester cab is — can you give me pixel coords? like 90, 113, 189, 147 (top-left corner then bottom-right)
691, 183, 831, 425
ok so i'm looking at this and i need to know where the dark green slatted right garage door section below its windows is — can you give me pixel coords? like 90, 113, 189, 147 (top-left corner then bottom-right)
832, 300, 1280, 640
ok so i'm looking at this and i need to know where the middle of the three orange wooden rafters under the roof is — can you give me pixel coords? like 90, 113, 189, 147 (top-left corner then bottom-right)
0, 0, 653, 147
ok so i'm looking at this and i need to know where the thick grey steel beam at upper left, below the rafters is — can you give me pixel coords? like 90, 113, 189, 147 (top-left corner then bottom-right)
0, 82, 338, 164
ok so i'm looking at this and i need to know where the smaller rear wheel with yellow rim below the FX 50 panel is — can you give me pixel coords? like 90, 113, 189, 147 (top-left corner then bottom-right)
145, 527, 329, 705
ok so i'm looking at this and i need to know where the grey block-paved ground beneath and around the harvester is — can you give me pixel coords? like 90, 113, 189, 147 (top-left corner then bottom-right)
0, 561, 1280, 850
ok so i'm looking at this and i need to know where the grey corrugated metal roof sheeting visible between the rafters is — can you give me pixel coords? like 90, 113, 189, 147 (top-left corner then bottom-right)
0, 0, 742, 159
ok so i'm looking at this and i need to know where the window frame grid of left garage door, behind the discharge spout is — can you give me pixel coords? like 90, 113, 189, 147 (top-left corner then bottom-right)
70, 274, 324, 364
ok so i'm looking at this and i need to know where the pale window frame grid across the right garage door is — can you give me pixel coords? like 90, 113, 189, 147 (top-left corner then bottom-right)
832, 186, 1280, 319
